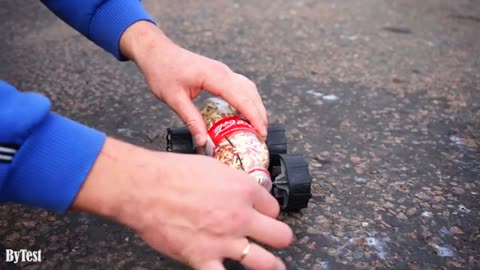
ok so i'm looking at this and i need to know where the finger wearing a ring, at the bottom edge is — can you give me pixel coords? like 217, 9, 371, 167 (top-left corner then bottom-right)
226, 239, 286, 270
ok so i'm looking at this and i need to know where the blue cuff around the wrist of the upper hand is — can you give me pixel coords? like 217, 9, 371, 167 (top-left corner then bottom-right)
89, 0, 155, 61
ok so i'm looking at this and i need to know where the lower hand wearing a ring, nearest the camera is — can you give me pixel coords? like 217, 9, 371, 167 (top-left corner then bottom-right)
72, 138, 292, 270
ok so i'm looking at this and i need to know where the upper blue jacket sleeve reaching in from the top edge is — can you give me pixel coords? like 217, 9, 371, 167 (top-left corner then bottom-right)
42, 0, 155, 60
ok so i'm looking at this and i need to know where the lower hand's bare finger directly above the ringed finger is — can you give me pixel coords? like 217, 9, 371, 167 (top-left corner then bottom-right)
246, 212, 293, 248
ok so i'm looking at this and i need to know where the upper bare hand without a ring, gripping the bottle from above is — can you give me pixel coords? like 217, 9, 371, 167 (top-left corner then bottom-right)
120, 21, 268, 146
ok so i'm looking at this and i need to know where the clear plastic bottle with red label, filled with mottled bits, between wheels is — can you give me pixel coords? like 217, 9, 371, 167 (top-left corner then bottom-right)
201, 97, 272, 191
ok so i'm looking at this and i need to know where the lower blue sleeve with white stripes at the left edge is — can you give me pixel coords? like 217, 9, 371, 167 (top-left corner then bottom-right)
0, 80, 106, 212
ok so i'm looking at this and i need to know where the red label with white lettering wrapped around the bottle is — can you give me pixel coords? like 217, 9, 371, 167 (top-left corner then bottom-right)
208, 116, 256, 146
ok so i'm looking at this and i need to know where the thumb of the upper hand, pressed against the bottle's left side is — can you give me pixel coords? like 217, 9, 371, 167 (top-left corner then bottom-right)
166, 91, 207, 146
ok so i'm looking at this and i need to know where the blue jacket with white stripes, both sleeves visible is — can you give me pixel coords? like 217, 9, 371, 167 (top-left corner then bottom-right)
0, 0, 153, 212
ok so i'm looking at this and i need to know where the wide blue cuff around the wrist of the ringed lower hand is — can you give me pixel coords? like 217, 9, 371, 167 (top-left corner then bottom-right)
5, 113, 106, 212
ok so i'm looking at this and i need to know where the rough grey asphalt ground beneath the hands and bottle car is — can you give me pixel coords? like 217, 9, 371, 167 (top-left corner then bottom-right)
0, 0, 480, 270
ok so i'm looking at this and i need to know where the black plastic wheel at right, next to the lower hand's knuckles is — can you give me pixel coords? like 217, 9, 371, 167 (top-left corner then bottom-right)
269, 154, 312, 211
